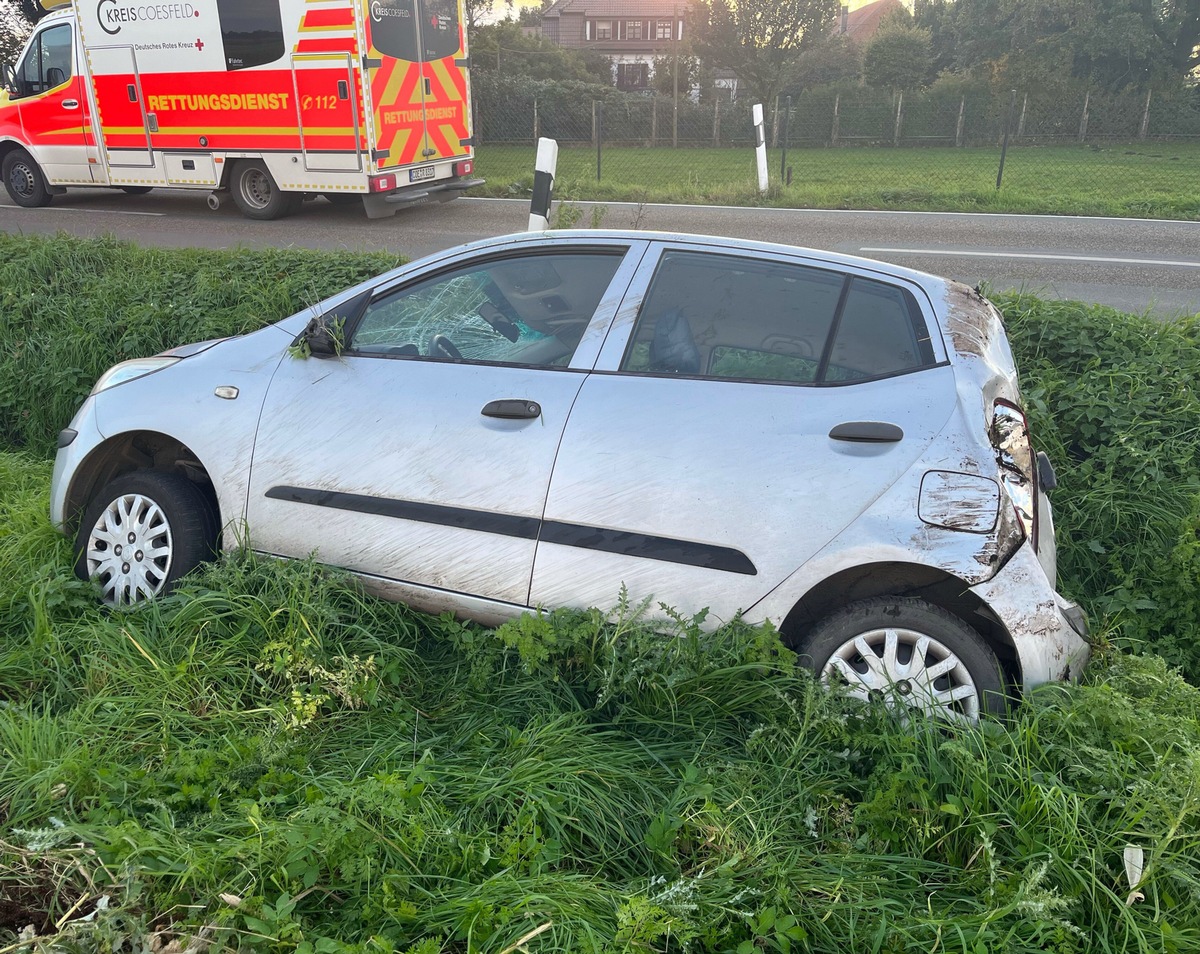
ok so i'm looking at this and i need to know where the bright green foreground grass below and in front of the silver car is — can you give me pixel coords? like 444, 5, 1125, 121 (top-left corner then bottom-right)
0, 454, 1200, 954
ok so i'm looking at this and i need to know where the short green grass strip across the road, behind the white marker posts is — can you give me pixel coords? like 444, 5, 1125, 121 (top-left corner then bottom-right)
474, 143, 1200, 220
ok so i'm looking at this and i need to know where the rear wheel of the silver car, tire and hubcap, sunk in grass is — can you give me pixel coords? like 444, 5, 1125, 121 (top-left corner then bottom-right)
796, 596, 1007, 722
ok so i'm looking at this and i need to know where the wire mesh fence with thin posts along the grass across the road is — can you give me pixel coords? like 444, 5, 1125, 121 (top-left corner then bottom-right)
474, 77, 1200, 217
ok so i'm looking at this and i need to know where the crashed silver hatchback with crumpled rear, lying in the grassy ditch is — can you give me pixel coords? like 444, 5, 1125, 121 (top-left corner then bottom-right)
52, 230, 1087, 719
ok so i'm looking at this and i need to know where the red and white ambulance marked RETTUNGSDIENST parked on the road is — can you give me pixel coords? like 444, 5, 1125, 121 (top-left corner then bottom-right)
0, 0, 481, 218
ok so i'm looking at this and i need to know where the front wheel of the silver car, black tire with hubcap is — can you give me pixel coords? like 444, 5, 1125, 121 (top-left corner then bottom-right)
76, 470, 218, 607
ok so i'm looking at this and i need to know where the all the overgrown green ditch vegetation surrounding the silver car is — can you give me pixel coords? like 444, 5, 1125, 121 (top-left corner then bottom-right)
0, 236, 1200, 954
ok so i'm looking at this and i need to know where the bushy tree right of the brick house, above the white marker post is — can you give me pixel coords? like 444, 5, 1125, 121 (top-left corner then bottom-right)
689, 0, 841, 104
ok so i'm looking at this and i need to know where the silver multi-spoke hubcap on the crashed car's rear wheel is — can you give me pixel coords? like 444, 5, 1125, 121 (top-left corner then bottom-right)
821, 628, 979, 722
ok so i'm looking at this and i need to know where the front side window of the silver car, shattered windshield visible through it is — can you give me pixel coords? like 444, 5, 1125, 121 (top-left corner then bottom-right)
349, 248, 624, 367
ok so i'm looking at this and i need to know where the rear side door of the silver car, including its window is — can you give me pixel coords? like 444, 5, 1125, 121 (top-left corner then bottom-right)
530, 242, 955, 619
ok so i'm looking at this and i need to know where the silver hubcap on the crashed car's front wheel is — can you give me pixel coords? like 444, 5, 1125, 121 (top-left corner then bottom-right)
88, 493, 173, 606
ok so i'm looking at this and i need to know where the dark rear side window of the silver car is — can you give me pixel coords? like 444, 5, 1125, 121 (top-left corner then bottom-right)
620, 251, 934, 384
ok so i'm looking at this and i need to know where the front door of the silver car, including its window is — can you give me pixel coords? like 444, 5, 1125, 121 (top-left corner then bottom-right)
247, 241, 644, 606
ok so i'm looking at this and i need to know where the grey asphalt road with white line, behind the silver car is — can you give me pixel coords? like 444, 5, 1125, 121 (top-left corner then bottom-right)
0, 190, 1200, 317
